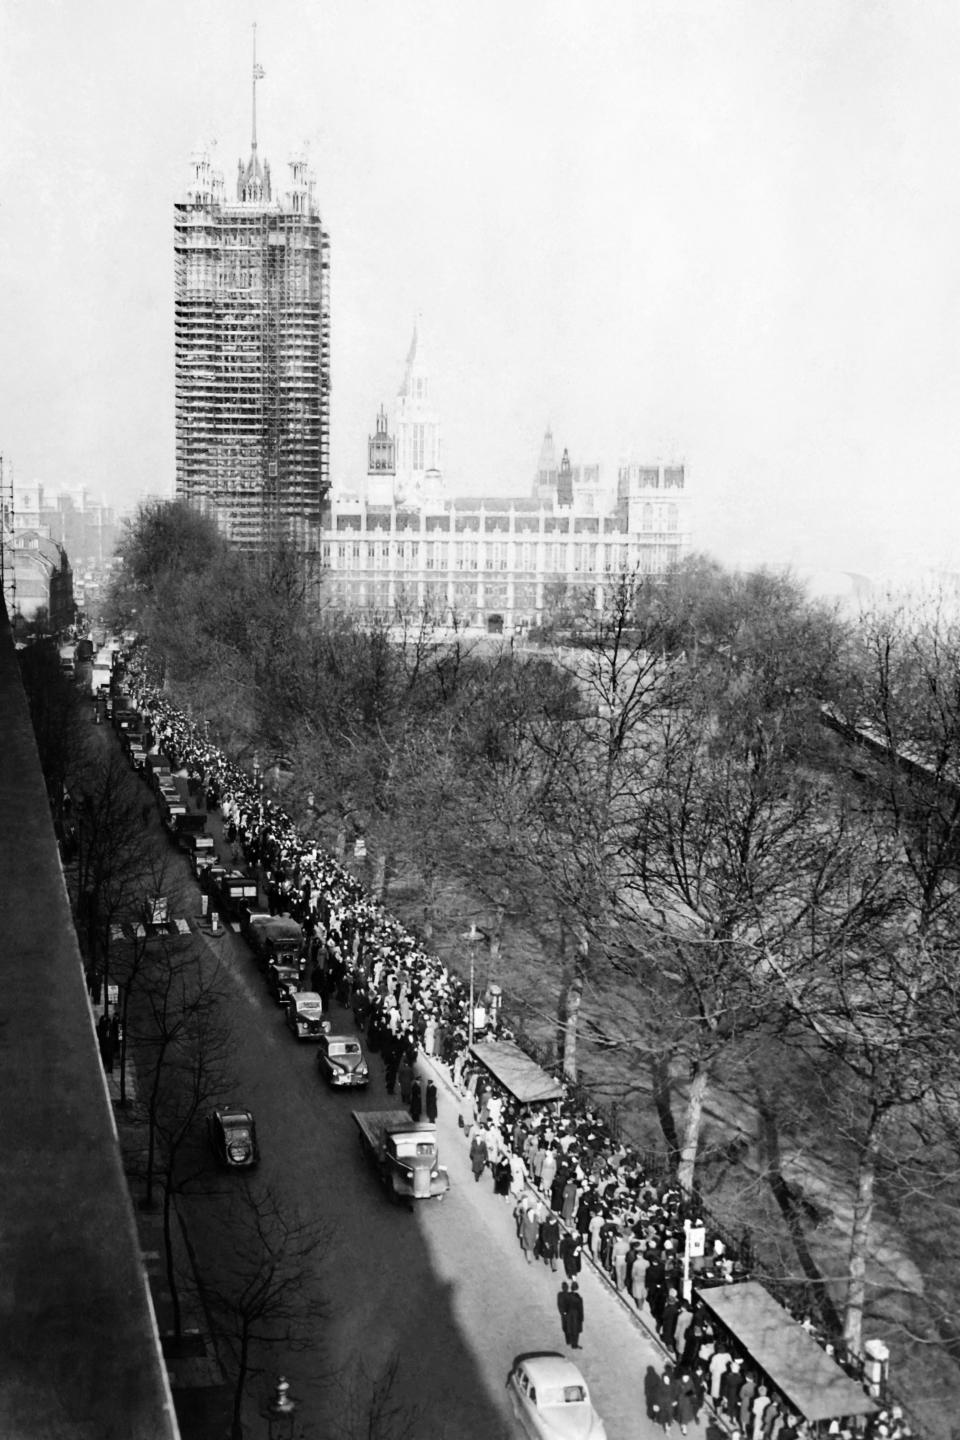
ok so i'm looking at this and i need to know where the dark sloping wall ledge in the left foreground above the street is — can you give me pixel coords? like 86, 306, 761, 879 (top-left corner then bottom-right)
0, 602, 177, 1440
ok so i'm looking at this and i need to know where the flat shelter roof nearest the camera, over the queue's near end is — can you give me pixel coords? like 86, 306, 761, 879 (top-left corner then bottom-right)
697, 1280, 877, 1423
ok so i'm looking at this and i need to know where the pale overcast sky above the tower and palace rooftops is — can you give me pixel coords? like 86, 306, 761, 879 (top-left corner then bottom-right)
0, 0, 960, 573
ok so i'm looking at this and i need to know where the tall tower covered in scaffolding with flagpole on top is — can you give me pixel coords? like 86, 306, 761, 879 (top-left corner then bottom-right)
174, 32, 330, 550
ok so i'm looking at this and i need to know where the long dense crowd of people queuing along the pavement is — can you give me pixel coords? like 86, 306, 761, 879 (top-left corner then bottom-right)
118, 661, 911, 1440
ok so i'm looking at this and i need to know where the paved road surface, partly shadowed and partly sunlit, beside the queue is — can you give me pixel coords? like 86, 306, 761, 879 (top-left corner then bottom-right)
105, 717, 721, 1440
